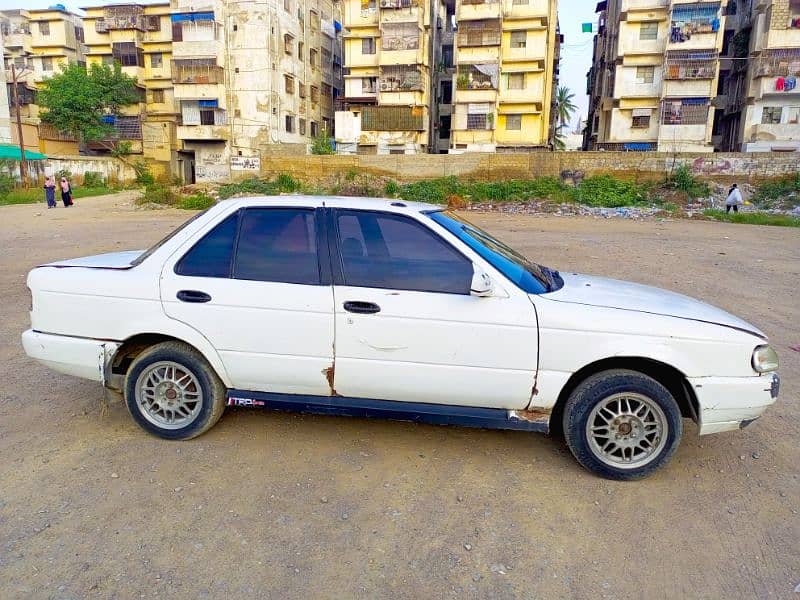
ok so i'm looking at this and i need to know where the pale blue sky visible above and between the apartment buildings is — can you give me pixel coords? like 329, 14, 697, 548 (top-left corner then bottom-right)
15, 0, 597, 125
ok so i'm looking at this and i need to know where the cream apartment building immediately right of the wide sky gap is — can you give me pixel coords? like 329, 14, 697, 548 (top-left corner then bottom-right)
584, 0, 727, 152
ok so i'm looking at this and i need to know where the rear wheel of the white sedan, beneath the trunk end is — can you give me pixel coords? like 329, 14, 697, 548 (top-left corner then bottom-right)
125, 342, 227, 440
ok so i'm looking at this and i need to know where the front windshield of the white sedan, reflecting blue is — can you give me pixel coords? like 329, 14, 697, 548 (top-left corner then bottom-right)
427, 211, 564, 294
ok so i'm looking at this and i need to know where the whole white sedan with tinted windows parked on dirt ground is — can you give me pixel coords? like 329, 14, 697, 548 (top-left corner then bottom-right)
22, 196, 779, 479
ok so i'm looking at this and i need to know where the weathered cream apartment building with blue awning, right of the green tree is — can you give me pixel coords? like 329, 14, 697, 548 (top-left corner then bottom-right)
171, 0, 342, 181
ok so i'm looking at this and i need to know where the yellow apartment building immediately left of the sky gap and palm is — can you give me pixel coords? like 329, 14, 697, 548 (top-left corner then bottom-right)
450, 0, 561, 153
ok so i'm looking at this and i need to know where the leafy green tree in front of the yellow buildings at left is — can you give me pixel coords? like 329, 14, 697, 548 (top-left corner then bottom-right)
38, 64, 141, 142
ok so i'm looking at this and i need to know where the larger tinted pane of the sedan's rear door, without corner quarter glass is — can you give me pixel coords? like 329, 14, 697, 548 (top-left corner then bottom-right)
233, 208, 320, 285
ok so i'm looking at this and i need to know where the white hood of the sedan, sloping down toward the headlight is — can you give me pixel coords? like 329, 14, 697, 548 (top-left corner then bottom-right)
543, 273, 766, 339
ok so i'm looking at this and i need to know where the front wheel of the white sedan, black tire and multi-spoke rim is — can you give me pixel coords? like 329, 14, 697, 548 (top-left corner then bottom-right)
563, 369, 683, 481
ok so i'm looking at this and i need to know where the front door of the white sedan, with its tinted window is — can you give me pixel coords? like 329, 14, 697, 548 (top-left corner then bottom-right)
329, 209, 538, 409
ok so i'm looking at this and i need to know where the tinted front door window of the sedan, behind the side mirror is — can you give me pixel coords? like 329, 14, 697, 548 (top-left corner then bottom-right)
337, 211, 473, 294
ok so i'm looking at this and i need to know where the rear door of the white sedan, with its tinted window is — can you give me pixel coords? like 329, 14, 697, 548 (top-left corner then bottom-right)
161, 207, 334, 395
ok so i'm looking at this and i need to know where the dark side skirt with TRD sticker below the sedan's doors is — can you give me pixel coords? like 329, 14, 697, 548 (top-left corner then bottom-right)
228, 390, 549, 433
